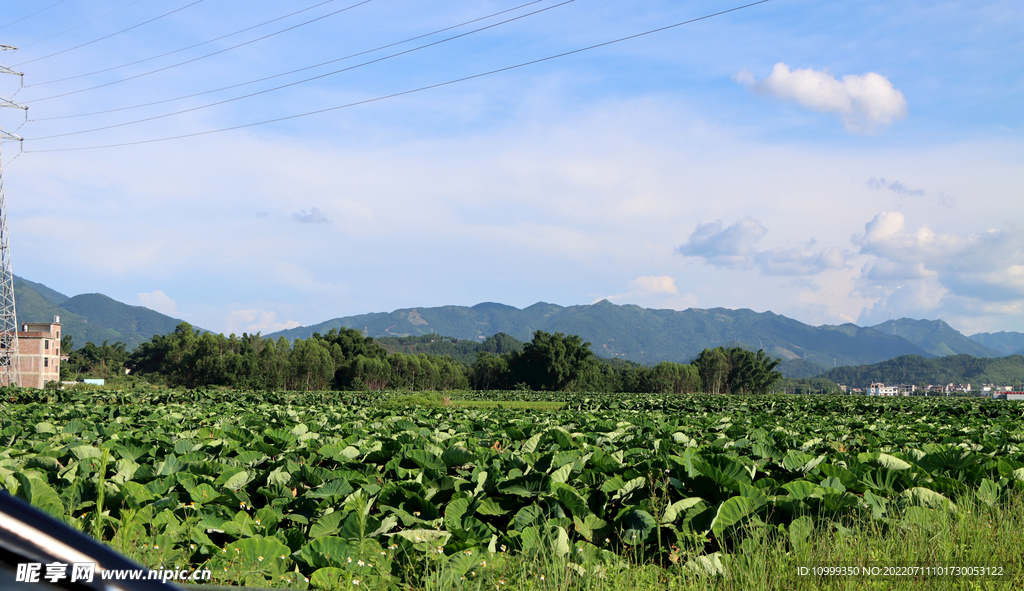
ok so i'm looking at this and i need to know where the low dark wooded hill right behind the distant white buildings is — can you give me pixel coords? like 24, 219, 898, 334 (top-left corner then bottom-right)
818, 354, 1024, 389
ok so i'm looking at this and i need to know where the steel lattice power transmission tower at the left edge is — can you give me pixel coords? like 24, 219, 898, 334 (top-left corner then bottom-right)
0, 45, 28, 386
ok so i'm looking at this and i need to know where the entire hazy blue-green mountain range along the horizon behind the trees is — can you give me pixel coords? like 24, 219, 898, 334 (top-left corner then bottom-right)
14, 277, 1024, 377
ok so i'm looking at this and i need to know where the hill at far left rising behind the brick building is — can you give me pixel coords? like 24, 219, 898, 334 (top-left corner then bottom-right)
14, 276, 197, 349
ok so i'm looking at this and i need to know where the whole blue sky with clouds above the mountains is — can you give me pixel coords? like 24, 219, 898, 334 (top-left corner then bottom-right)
0, 0, 1024, 334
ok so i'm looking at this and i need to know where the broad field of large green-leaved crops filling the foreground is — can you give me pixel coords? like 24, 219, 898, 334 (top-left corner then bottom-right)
0, 390, 1024, 589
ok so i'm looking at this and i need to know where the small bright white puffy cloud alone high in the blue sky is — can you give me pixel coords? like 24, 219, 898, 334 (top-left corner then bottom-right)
733, 61, 906, 133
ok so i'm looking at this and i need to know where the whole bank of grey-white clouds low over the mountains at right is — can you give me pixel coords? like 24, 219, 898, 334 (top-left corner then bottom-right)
676, 211, 1024, 331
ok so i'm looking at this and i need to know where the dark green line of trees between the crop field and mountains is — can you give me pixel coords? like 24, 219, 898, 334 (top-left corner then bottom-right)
61, 323, 781, 393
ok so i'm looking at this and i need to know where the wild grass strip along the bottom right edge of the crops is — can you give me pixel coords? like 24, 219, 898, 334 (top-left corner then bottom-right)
174, 495, 1024, 591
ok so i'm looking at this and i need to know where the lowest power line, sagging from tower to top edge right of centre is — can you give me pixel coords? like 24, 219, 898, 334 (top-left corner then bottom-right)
25, 0, 768, 153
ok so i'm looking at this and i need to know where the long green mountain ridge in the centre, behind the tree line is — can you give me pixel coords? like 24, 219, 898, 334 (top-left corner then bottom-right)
269, 300, 933, 374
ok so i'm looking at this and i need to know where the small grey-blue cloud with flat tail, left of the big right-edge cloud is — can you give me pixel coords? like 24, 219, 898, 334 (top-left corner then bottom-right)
676, 217, 850, 276
